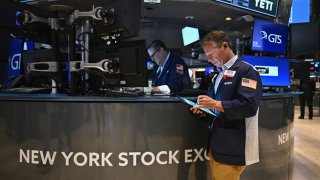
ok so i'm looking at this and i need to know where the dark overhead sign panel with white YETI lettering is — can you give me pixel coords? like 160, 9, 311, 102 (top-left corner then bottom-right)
215, 0, 279, 17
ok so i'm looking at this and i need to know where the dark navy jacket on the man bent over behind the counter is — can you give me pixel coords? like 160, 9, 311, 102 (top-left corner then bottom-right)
152, 53, 190, 92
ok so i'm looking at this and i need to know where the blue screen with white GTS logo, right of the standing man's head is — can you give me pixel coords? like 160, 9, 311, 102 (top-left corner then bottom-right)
251, 20, 288, 54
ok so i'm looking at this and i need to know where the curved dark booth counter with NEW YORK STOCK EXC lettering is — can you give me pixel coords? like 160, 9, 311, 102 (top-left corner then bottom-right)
0, 94, 294, 180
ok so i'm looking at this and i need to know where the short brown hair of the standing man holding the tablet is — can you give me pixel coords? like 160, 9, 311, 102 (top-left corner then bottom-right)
201, 31, 231, 48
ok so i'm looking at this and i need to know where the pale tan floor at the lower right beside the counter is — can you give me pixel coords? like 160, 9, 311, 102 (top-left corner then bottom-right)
292, 106, 320, 180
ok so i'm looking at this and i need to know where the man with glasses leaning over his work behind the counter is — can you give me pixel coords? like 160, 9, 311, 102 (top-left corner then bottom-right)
147, 40, 190, 94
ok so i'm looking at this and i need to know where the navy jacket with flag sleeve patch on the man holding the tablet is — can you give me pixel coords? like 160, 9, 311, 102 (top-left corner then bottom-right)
208, 59, 262, 165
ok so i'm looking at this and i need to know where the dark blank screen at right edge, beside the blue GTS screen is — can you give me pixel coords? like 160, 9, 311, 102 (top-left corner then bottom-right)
290, 23, 320, 57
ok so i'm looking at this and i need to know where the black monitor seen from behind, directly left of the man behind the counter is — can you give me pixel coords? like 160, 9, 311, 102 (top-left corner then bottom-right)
90, 40, 149, 87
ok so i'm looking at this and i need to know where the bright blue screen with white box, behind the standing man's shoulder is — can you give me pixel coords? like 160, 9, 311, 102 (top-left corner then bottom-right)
242, 56, 290, 87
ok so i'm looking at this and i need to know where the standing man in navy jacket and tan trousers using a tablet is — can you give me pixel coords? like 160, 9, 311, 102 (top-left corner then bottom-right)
191, 31, 262, 180
